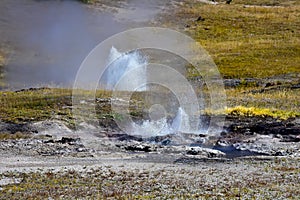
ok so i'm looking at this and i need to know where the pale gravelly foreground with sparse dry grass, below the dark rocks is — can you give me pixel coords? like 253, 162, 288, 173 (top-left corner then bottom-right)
0, 136, 300, 199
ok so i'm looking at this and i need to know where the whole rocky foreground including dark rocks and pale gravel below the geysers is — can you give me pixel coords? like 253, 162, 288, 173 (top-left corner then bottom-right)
0, 114, 300, 199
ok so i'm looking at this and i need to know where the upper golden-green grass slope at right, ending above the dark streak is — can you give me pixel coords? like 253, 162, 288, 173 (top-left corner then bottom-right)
171, 1, 300, 78
